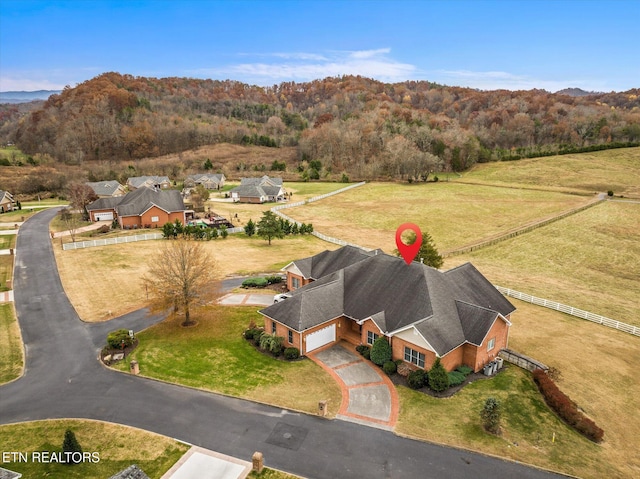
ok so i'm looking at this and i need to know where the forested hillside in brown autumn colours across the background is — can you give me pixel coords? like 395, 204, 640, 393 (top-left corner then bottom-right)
0, 73, 640, 179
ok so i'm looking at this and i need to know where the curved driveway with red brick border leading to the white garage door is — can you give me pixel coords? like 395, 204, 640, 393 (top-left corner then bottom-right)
307, 341, 400, 430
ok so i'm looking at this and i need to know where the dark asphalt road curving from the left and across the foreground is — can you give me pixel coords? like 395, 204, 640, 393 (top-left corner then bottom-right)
0, 210, 559, 479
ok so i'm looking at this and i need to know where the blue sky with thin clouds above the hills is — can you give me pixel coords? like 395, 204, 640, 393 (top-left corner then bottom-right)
0, 0, 640, 91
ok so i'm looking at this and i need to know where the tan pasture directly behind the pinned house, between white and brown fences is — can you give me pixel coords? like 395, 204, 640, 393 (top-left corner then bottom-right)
285, 182, 592, 253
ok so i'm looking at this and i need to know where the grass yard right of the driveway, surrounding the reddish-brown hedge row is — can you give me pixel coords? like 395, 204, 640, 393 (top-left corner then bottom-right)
396, 301, 640, 479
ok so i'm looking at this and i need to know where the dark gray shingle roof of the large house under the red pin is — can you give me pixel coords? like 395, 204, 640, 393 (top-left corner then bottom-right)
260, 253, 515, 356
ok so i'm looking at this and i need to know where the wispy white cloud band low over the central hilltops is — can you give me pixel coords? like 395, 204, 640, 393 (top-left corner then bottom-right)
191, 48, 416, 84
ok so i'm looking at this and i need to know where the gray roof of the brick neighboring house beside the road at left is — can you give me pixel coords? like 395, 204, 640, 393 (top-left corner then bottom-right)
87, 187, 185, 216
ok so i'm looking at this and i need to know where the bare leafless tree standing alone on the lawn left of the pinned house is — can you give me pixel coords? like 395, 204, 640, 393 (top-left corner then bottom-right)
143, 240, 216, 326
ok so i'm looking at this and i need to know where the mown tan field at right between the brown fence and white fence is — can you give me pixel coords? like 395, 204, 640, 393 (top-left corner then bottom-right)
445, 201, 640, 326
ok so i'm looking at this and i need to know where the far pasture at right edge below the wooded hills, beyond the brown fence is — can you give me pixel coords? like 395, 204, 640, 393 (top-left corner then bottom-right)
464, 147, 640, 198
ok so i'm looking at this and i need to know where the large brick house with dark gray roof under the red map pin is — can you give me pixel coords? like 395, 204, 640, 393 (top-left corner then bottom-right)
260, 252, 515, 371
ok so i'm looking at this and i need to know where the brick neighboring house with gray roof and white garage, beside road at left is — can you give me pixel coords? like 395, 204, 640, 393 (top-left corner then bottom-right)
87, 187, 186, 229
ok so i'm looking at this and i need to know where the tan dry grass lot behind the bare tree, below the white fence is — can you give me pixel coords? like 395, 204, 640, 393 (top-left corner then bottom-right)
55, 234, 337, 321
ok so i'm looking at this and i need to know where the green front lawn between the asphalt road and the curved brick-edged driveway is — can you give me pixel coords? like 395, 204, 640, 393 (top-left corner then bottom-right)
114, 306, 341, 416
